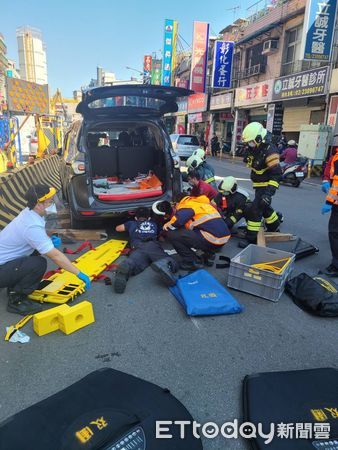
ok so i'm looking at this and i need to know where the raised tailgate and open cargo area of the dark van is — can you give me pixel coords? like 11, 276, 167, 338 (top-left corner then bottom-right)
76, 85, 193, 201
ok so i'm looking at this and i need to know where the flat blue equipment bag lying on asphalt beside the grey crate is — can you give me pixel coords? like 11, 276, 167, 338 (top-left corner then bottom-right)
169, 269, 243, 316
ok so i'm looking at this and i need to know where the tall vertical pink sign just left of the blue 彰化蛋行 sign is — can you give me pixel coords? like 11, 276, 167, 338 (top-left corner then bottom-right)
190, 22, 209, 92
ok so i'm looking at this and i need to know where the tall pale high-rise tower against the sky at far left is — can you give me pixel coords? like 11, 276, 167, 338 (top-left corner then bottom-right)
16, 27, 48, 84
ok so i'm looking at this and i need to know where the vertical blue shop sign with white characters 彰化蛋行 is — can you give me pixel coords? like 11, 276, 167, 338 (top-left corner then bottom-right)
212, 41, 235, 89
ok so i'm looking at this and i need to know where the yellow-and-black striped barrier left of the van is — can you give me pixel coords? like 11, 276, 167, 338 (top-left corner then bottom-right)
0, 155, 64, 229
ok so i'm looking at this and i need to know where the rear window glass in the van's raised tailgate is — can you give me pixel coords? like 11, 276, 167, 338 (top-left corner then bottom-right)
88, 95, 166, 110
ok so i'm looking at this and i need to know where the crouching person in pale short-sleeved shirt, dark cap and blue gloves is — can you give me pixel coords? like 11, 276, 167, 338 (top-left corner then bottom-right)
0, 184, 90, 315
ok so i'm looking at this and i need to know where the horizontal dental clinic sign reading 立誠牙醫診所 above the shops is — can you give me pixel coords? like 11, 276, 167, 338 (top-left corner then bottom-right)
272, 66, 328, 101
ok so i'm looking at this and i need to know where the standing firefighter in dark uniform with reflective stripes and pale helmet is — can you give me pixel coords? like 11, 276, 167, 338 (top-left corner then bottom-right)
242, 122, 282, 243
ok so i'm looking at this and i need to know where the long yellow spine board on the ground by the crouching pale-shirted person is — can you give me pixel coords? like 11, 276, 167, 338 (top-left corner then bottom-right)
29, 239, 127, 304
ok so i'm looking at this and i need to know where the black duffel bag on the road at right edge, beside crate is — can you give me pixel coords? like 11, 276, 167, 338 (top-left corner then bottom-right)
285, 273, 338, 317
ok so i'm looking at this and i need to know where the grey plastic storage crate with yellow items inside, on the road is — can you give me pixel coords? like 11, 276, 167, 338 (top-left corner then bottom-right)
228, 244, 295, 302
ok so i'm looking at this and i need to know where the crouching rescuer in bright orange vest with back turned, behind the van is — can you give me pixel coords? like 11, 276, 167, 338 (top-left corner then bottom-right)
163, 195, 230, 270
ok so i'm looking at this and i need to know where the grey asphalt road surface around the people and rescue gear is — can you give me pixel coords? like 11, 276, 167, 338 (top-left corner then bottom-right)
0, 158, 338, 450
